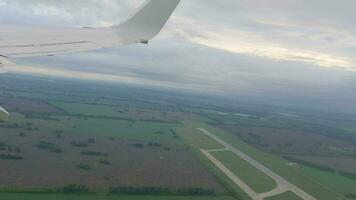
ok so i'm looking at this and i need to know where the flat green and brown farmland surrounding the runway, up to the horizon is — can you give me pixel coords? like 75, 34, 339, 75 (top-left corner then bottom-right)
0, 74, 356, 200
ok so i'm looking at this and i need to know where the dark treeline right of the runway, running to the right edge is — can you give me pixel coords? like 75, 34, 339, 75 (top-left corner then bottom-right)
283, 156, 356, 180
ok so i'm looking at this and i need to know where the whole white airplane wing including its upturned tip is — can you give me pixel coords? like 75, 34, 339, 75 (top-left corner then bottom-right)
0, 0, 180, 58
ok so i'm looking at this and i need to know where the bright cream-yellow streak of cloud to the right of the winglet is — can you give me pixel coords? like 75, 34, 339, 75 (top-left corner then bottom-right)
167, 18, 356, 71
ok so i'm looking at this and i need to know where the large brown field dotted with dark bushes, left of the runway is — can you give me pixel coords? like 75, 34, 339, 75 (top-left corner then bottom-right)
0, 128, 224, 192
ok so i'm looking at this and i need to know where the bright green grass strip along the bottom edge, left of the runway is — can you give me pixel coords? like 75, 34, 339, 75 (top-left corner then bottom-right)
0, 193, 234, 200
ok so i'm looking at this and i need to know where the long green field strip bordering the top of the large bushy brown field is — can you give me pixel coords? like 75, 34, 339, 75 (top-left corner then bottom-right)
8, 113, 181, 144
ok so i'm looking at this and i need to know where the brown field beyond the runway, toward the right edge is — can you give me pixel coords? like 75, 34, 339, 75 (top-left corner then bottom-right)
221, 125, 355, 156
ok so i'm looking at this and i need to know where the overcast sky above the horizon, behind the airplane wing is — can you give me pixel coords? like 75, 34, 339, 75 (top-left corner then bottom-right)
0, 0, 356, 110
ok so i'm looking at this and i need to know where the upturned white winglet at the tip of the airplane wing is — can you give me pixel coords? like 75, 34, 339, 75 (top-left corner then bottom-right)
113, 0, 180, 44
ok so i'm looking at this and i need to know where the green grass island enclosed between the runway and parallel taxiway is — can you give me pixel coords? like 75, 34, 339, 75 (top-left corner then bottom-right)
211, 151, 277, 193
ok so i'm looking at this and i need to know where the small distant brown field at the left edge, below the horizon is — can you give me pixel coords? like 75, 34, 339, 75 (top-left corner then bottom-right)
0, 96, 63, 114
